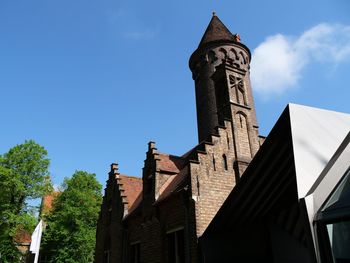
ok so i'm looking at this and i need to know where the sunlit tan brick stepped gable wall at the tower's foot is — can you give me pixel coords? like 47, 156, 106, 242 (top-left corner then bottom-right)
190, 122, 236, 236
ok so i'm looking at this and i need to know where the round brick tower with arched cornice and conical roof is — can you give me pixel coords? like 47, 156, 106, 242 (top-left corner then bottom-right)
189, 13, 259, 176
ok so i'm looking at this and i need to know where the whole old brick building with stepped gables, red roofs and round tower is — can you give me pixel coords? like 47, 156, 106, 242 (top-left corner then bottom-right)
95, 14, 263, 263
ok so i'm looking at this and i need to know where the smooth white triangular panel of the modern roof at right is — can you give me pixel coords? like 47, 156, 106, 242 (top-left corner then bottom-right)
289, 104, 350, 198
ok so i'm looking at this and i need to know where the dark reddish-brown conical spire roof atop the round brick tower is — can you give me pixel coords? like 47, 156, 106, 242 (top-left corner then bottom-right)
198, 12, 237, 48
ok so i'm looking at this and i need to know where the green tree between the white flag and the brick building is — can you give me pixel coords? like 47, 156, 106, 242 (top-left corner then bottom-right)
43, 171, 102, 263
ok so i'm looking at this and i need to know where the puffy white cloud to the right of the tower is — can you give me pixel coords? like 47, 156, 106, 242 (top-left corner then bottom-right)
251, 23, 350, 95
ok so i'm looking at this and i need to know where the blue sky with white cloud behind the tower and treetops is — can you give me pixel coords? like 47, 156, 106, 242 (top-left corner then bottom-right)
0, 0, 350, 190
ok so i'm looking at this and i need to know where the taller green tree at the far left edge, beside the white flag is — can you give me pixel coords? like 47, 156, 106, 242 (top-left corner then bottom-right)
0, 140, 51, 262
